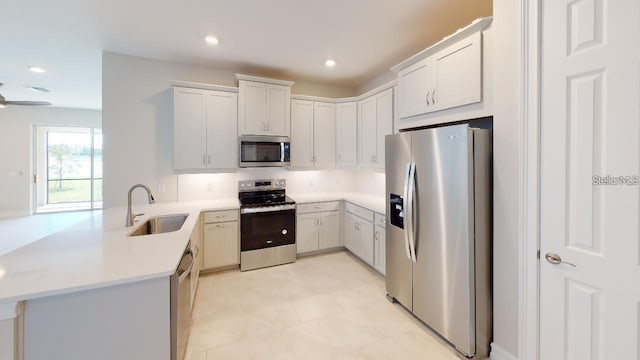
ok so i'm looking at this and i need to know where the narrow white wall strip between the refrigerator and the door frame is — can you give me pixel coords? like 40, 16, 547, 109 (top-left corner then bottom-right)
492, 0, 522, 359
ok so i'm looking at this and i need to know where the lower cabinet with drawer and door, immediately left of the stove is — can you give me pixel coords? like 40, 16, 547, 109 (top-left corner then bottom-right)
202, 210, 240, 270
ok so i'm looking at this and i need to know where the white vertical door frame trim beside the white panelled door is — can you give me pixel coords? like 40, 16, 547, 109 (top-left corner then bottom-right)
517, 0, 542, 360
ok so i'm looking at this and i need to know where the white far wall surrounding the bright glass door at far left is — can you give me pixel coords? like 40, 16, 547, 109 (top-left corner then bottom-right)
0, 106, 102, 217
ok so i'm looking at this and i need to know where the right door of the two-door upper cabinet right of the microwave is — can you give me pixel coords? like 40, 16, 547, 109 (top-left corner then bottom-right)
313, 102, 336, 169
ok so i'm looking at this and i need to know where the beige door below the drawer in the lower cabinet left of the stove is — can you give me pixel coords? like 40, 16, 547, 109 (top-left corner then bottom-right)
203, 221, 240, 269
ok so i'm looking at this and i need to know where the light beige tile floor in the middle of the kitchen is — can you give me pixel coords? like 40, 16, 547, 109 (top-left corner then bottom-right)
186, 252, 458, 360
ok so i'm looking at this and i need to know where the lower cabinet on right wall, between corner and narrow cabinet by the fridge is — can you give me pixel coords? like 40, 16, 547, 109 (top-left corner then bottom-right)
344, 208, 374, 266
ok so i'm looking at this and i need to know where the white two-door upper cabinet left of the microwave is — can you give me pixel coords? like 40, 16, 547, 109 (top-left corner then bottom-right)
173, 87, 238, 171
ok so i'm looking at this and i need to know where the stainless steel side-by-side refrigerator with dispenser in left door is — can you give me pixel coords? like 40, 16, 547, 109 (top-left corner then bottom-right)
385, 124, 492, 358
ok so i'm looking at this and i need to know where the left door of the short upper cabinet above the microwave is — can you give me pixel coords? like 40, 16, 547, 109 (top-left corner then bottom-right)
238, 80, 267, 135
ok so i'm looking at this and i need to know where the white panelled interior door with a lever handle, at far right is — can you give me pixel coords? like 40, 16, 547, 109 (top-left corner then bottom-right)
540, 0, 640, 360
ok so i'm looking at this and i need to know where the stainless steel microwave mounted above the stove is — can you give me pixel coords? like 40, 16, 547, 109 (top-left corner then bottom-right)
238, 136, 291, 167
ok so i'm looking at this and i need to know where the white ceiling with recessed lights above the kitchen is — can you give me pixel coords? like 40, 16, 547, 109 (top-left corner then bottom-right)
0, 0, 492, 109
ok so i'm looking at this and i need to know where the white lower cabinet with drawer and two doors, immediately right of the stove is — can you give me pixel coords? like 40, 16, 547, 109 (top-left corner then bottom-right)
296, 202, 342, 254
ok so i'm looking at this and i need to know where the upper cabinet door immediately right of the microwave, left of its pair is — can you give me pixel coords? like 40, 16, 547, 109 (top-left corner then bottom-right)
291, 100, 313, 168
